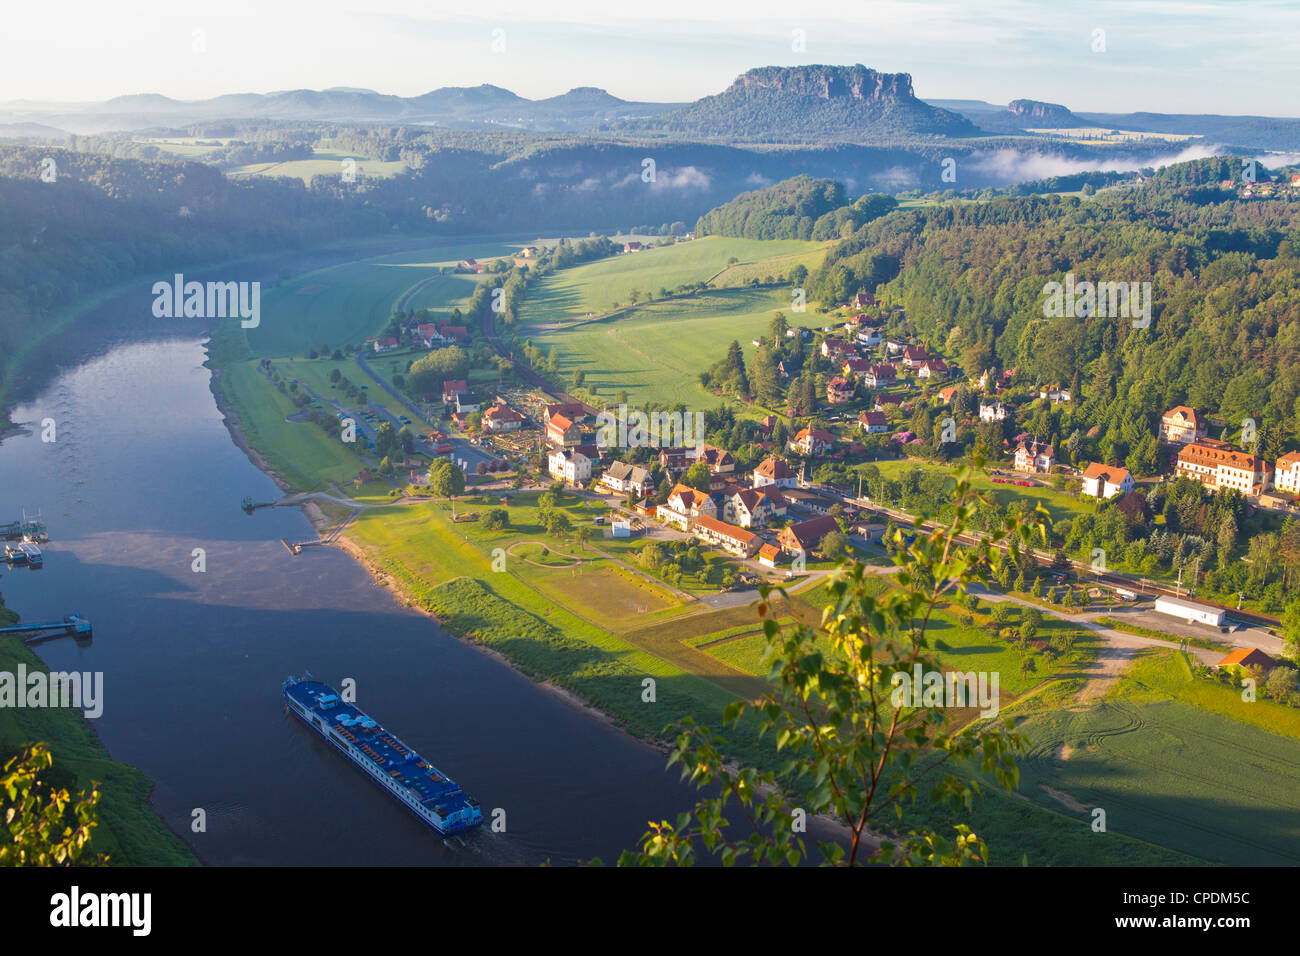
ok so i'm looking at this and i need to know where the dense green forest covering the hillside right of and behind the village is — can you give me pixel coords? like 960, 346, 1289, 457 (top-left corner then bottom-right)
809, 157, 1300, 447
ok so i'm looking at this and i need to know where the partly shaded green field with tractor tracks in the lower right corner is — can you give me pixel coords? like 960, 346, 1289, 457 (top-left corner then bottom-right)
1021, 650, 1300, 866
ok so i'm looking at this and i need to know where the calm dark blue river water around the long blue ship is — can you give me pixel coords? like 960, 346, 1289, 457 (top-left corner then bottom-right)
0, 334, 722, 865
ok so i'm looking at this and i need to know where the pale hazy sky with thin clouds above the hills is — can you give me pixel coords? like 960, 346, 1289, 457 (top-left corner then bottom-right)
0, 0, 1300, 116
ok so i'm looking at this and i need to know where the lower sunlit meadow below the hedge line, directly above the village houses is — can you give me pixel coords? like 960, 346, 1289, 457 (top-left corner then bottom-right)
532, 289, 789, 410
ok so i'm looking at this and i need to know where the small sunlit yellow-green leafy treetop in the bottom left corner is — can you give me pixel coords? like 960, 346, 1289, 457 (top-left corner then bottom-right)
0, 744, 108, 866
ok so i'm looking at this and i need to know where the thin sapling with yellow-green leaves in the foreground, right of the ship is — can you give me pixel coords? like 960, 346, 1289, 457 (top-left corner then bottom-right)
619, 470, 1026, 866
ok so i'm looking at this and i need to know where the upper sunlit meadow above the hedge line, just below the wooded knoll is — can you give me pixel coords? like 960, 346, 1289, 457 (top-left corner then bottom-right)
520, 235, 826, 325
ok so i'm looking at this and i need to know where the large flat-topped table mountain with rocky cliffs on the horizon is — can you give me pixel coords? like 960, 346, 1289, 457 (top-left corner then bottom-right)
628, 64, 980, 143
